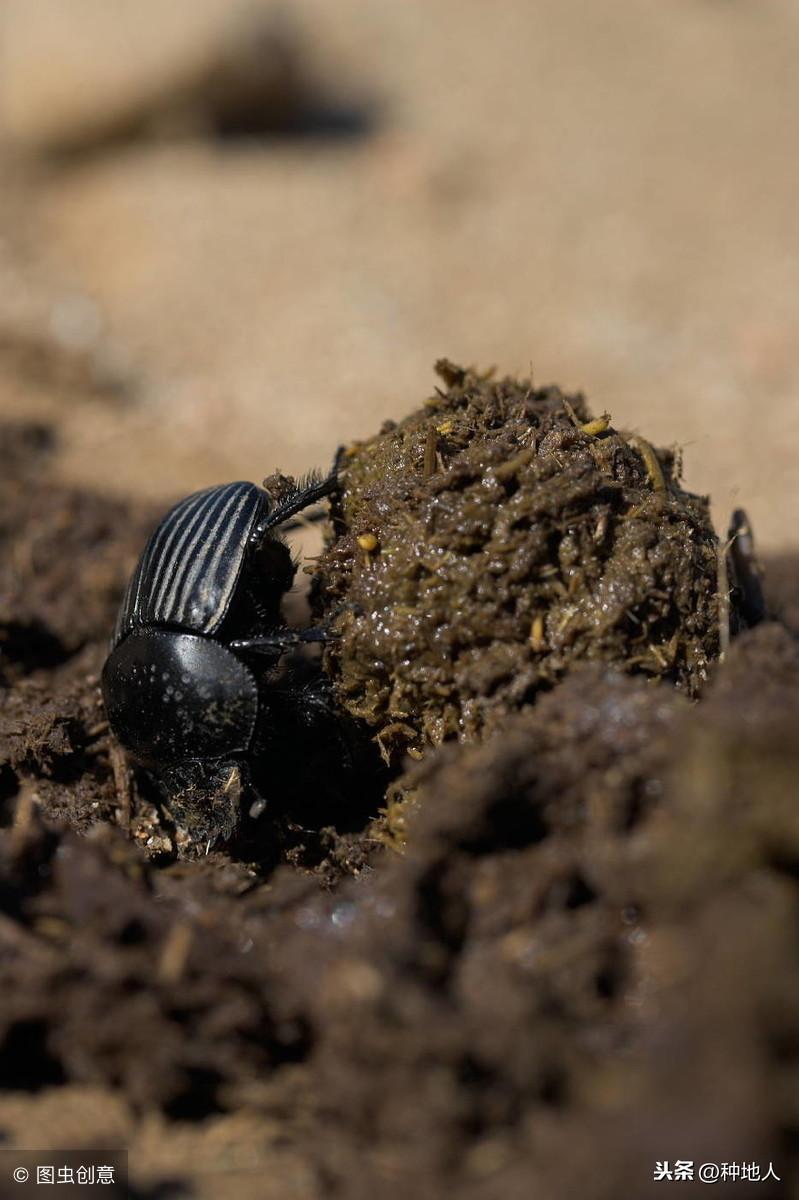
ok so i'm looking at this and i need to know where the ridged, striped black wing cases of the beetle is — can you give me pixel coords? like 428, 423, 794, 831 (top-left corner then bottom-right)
112, 482, 263, 648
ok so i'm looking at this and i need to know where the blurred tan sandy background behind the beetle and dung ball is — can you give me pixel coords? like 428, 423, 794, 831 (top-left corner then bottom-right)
0, 0, 799, 550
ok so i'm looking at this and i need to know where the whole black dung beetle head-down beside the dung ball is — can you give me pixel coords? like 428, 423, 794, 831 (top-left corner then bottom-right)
102, 468, 336, 842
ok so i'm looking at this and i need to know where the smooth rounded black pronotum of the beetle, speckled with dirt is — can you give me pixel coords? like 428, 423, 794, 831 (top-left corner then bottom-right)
102, 629, 258, 768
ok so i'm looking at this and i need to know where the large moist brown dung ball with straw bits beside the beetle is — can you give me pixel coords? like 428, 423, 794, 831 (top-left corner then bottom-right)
316, 361, 719, 755
